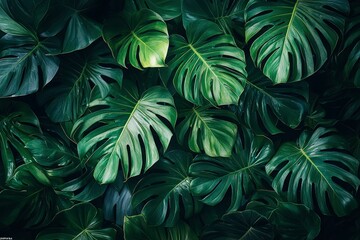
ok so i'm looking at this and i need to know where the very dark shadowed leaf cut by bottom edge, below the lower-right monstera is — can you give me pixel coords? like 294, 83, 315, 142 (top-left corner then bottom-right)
246, 190, 320, 240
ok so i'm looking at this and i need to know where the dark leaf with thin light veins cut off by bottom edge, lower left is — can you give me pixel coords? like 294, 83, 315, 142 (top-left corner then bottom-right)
36, 203, 116, 240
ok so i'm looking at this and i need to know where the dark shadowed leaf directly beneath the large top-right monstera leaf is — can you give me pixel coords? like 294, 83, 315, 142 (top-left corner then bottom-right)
237, 64, 309, 135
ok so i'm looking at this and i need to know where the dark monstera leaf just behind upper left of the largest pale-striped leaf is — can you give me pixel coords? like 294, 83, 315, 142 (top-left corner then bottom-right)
39, 41, 122, 122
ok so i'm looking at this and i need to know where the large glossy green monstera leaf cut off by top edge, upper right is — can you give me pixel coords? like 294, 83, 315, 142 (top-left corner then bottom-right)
245, 0, 349, 83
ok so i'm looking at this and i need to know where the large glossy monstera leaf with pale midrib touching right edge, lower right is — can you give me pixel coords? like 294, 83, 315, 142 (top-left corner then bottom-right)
266, 128, 360, 216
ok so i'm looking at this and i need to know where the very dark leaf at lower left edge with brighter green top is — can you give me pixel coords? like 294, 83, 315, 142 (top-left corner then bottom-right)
0, 163, 71, 228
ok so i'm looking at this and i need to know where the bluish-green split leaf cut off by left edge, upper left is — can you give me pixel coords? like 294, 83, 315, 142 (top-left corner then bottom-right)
0, 34, 59, 97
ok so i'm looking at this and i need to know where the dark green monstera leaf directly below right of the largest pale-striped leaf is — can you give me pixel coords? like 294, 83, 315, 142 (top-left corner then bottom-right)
132, 151, 200, 227
